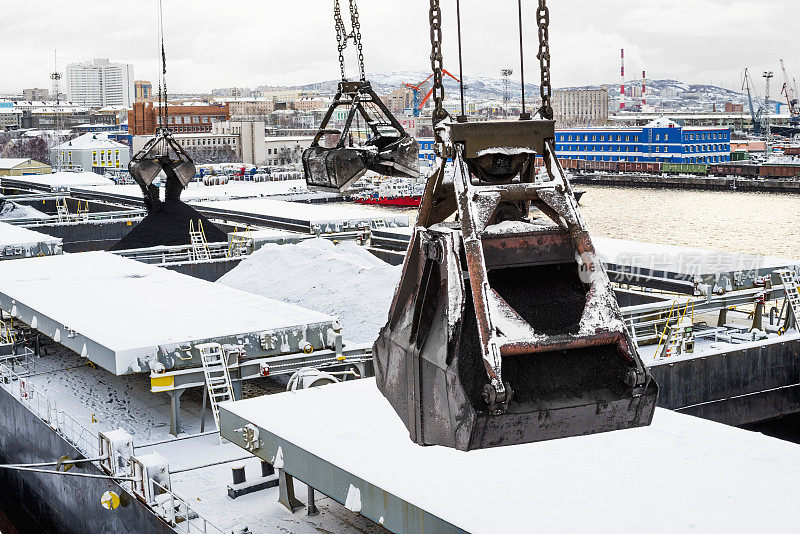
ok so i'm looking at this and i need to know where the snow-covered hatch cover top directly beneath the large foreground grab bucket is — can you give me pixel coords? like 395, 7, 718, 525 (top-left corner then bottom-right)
224, 379, 800, 534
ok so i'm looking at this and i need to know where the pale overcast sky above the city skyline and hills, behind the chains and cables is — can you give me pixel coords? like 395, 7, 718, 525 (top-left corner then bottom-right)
0, 0, 800, 95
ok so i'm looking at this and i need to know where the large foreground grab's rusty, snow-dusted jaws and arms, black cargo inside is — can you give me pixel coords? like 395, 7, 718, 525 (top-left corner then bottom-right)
373, 122, 658, 450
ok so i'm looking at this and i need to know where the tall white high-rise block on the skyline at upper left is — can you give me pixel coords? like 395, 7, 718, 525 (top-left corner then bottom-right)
66, 59, 135, 108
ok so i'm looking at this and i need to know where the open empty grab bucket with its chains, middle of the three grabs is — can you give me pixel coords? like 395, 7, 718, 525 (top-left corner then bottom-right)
302, 0, 419, 192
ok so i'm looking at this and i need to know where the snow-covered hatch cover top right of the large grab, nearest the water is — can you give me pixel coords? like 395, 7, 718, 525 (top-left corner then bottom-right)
592, 237, 800, 274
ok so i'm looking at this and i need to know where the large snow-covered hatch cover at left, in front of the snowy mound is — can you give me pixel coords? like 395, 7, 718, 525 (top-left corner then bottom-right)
0, 252, 333, 374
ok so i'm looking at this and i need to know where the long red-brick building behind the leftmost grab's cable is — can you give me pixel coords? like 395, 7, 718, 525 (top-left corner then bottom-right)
128, 102, 231, 135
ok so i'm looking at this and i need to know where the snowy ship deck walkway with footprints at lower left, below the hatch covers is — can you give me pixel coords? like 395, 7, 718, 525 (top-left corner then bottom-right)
0, 345, 386, 534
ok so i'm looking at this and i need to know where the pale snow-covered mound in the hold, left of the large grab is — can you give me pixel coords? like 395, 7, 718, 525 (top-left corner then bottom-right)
218, 239, 402, 343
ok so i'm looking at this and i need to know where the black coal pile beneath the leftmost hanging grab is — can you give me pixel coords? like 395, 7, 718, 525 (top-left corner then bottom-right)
111, 200, 228, 250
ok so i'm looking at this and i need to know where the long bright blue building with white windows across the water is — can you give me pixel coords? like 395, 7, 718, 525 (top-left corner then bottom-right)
556, 118, 731, 163
